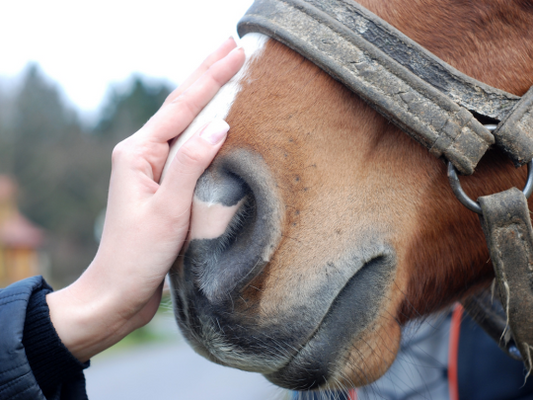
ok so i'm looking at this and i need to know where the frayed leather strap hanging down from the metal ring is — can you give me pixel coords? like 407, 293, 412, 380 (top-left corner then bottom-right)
478, 188, 533, 372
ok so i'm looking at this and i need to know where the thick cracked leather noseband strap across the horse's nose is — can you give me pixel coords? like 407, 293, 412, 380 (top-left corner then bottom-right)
238, 0, 520, 174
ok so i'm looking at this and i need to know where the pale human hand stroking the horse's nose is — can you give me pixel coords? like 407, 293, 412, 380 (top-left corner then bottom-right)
47, 39, 244, 362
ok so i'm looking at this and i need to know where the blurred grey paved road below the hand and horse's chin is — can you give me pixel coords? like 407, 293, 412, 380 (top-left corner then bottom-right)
85, 341, 286, 400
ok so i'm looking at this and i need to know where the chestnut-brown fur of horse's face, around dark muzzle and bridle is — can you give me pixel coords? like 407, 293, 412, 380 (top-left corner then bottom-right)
170, 0, 533, 388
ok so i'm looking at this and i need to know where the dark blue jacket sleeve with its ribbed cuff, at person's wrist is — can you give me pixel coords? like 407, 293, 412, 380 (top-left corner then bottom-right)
0, 276, 89, 400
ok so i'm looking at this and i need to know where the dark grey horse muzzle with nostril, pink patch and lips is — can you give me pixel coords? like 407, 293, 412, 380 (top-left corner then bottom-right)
170, 149, 396, 390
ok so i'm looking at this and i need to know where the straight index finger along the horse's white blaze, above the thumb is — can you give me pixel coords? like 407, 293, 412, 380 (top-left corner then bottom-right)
139, 48, 245, 144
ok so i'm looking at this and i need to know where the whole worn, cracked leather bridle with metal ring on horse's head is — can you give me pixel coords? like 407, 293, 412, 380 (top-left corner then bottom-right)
237, 0, 533, 371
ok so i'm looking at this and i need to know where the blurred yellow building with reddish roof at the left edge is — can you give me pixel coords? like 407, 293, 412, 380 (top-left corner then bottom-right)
0, 175, 43, 287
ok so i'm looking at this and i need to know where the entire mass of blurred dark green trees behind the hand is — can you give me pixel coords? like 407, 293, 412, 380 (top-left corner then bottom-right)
0, 64, 171, 289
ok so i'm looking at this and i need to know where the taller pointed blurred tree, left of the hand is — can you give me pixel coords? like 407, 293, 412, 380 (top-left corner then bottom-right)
0, 64, 108, 285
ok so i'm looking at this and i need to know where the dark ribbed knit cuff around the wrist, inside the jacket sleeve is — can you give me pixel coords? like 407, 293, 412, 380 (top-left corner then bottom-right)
22, 288, 89, 397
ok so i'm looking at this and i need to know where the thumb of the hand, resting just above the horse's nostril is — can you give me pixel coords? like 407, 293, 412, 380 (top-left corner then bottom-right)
156, 120, 229, 206
